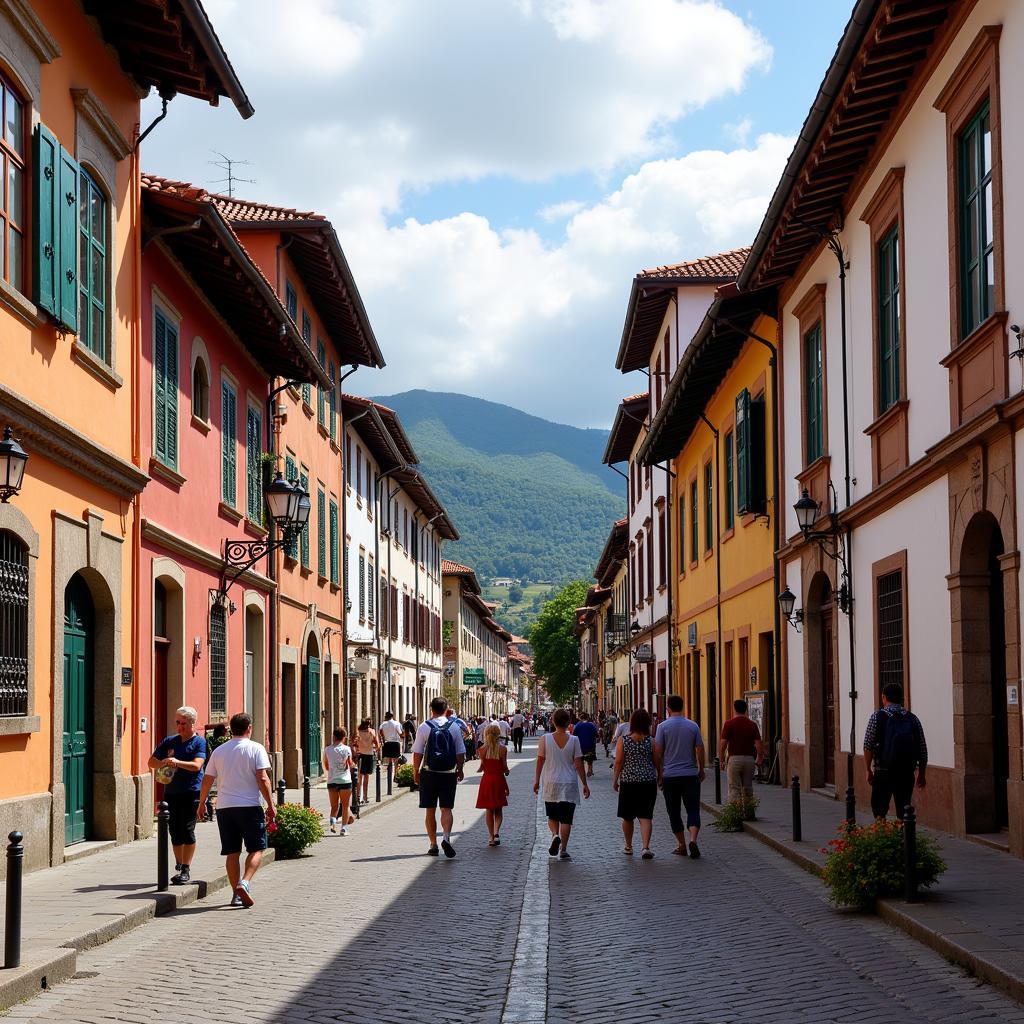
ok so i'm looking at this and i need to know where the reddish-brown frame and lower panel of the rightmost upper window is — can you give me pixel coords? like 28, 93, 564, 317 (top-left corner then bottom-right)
934, 25, 1010, 430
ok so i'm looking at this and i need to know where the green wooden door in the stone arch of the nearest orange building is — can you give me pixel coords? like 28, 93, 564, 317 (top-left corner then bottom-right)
63, 575, 94, 846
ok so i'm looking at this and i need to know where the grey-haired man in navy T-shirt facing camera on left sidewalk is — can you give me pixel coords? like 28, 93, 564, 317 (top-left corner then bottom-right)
150, 708, 206, 886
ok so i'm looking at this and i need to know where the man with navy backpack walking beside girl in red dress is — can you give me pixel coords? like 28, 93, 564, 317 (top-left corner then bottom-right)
413, 697, 466, 858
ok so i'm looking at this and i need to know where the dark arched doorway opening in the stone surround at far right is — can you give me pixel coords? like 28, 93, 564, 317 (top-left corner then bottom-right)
950, 511, 1010, 833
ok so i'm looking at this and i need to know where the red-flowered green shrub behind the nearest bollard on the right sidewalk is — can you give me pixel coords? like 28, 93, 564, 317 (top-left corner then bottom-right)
821, 818, 946, 909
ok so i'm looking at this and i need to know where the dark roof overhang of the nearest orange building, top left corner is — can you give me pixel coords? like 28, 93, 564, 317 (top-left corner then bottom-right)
81, 0, 253, 118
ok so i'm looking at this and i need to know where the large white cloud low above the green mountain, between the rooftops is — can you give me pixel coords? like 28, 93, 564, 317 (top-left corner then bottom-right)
339, 135, 793, 425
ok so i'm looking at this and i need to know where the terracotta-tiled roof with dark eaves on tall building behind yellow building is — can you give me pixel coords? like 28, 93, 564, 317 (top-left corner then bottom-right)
615, 249, 750, 374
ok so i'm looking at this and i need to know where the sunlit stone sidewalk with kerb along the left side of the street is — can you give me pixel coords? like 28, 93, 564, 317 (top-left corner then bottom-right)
0, 784, 407, 1010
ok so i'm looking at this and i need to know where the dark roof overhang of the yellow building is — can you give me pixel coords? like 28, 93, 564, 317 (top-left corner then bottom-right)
637, 289, 776, 466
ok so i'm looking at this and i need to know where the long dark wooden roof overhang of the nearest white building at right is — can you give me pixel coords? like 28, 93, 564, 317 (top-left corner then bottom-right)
738, 0, 958, 291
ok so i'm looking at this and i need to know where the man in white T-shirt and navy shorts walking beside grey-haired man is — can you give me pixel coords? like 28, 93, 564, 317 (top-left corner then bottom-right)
199, 714, 276, 908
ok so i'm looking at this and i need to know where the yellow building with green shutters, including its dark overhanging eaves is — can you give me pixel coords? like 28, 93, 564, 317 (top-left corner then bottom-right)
641, 299, 779, 757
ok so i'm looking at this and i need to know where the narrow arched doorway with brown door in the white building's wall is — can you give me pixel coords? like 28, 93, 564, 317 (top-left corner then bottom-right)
804, 572, 837, 786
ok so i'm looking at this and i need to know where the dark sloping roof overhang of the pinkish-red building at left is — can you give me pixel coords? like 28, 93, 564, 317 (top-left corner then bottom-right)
142, 185, 332, 388
